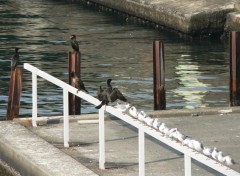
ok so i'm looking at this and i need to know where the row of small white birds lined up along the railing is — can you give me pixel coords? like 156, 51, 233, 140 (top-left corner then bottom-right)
115, 104, 235, 165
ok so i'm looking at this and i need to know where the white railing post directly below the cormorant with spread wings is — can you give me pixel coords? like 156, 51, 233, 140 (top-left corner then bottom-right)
99, 106, 105, 169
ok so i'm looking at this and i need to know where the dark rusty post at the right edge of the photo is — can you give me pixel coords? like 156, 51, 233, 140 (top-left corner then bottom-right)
229, 32, 240, 106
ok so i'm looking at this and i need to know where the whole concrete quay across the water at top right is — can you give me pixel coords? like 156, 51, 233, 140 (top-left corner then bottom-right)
85, 0, 240, 36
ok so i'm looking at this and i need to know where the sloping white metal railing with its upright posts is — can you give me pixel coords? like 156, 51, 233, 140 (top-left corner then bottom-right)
24, 63, 240, 176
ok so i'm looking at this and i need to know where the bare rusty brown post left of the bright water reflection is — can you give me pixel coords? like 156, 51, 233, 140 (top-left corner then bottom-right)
153, 40, 166, 110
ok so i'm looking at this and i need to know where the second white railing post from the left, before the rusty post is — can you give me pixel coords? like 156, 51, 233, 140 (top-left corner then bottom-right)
63, 89, 69, 147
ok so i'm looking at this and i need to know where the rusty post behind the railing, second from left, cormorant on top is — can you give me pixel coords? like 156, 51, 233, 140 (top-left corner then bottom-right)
68, 51, 81, 115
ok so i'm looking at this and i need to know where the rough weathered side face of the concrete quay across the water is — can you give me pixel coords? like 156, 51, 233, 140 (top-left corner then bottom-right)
84, 0, 238, 36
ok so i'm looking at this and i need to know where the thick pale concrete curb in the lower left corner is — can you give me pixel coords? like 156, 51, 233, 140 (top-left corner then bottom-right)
0, 121, 97, 176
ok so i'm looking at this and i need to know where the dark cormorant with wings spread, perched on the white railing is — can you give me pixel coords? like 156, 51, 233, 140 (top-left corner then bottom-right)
95, 79, 127, 109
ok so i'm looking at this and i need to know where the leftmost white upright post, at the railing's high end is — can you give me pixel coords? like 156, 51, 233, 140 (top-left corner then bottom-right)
32, 73, 37, 127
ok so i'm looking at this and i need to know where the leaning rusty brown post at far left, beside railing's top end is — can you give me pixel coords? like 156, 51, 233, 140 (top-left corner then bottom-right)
6, 67, 23, 120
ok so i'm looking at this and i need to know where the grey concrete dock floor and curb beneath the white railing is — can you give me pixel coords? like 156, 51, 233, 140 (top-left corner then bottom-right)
0, 108, 240, 176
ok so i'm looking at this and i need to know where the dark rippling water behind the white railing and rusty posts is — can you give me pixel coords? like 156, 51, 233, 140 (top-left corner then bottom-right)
0, 0, 229, 118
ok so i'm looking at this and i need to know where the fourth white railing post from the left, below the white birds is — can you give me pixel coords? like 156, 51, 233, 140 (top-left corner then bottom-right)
138, 129, 145, 176
